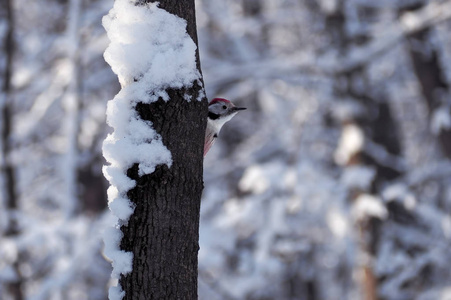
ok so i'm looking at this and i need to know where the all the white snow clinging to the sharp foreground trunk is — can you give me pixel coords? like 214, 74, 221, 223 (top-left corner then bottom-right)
102, 0, 201, 299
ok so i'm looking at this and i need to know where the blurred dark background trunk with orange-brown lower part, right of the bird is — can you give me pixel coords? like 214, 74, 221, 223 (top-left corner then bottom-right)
326, 0, 402, 300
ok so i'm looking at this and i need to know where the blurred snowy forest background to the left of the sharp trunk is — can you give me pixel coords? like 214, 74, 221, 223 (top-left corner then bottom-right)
0, 0, 117, 299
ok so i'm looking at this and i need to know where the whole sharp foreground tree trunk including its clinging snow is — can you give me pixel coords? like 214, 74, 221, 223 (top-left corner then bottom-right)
103, 0, 207, 299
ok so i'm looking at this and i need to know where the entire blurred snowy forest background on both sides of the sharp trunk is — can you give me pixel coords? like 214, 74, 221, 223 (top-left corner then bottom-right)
0, 0, 451, 300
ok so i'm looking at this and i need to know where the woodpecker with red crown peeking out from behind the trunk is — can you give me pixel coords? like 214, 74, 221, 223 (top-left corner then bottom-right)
204, 98, 246, 157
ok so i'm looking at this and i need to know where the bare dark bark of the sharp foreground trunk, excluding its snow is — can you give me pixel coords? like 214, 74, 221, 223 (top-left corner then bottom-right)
116, 0, 207, 300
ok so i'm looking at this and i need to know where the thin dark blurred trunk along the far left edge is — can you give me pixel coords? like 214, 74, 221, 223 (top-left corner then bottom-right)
0, 0, 24, 300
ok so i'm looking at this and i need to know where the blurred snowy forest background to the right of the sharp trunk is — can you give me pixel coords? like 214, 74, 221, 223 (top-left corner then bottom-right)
199, 0, 451, 299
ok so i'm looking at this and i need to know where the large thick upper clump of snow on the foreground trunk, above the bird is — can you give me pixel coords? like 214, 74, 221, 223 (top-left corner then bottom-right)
103, 0, 200, 91
